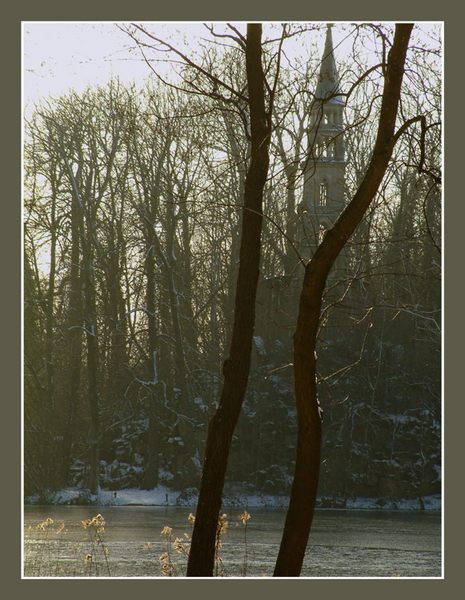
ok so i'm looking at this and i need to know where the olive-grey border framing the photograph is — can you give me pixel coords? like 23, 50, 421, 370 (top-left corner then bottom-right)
6, 0, 456, 600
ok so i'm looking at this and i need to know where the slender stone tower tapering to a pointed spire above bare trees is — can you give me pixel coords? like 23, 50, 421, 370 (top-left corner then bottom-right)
301, 25, 346, 259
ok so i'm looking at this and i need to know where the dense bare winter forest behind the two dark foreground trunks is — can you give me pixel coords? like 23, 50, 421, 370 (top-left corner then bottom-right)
23, 24, 442, 506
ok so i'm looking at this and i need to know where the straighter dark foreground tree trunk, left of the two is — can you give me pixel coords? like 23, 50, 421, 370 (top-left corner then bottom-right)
187, 24, 270, 577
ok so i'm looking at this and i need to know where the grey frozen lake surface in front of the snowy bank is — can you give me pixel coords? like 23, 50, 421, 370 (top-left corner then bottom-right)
24, 506, 441, 577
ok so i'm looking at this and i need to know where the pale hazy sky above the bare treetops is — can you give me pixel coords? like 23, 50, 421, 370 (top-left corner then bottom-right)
23, 22, 442, 111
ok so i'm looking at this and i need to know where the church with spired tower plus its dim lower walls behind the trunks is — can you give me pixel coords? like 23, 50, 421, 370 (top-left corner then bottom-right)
256, 25, 347, 346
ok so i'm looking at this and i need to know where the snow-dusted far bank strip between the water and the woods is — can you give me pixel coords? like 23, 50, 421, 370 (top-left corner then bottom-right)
25, 486, 441, 510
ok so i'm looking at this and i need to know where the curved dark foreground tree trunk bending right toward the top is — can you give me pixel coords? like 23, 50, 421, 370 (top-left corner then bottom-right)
274, 24, 412, 577
